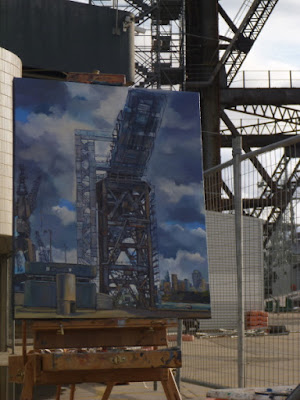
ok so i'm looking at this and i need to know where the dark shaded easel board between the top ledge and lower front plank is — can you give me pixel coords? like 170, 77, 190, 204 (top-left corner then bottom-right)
34, 326, 167, 350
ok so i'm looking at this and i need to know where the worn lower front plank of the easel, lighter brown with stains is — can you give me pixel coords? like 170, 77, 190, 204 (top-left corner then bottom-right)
41, 349, 181, 372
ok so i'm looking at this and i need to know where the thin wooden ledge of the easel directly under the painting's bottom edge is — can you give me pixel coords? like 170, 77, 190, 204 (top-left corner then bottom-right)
32, 318, 178, 332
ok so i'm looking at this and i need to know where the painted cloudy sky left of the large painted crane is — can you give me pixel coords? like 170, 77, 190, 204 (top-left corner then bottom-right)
15, 79, 127, 263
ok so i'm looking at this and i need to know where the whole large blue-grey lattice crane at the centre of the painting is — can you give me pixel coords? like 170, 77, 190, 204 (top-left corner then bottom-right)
75, 90, 166, 309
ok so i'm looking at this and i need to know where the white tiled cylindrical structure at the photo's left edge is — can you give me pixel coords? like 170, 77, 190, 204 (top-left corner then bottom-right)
0, 48, 22, 239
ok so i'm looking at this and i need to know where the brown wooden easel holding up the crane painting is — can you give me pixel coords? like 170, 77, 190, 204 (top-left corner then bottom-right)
9, 319, 181, 400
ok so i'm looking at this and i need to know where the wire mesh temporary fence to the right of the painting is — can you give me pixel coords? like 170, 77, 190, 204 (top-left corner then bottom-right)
173, 137, 300, 387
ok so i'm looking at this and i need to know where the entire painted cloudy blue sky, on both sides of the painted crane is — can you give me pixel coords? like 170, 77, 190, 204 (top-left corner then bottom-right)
15, 79, 208, 280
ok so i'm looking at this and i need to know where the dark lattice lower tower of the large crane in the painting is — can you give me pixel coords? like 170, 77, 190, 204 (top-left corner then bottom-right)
97, 177, 158, 309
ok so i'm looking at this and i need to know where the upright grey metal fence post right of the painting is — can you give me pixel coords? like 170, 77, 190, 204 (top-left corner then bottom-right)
232, 137, 245, 388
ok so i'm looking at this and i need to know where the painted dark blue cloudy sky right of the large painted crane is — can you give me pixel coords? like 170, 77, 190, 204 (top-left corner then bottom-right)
147, 92, 208, 281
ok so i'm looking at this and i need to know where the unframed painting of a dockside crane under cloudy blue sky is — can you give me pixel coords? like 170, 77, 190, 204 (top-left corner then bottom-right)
13, 79, 210, 319
